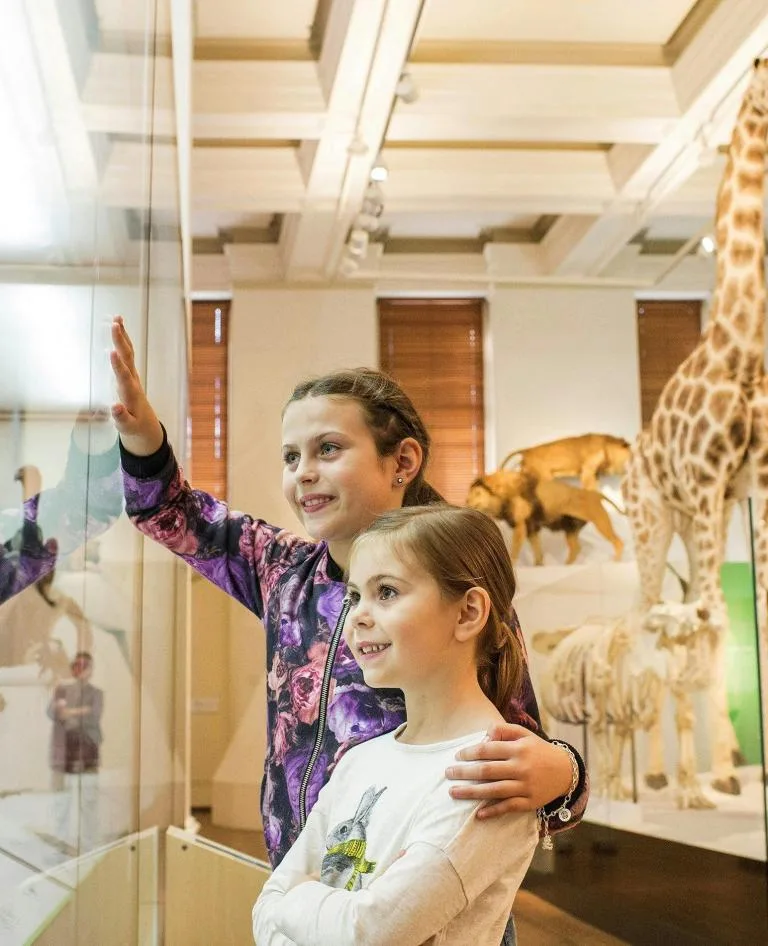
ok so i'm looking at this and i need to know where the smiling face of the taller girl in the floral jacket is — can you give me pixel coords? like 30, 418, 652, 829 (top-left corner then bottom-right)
283, 396, 403, 567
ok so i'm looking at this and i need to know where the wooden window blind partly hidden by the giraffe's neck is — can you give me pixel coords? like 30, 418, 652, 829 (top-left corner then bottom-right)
637, 299, 701, 427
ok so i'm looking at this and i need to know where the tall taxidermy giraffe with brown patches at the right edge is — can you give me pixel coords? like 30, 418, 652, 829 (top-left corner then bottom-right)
622, 61, 768, 798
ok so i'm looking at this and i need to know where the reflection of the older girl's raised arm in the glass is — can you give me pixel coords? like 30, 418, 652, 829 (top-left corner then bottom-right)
0, 410, 122, 604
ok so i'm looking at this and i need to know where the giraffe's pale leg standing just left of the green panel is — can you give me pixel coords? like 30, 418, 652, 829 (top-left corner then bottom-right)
693, 491, 741, 795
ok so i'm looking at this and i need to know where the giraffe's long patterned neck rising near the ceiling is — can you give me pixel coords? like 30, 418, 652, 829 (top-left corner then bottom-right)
712, 99, 768, 376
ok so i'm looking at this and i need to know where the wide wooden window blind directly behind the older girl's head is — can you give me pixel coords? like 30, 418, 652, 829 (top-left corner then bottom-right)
379, 299, 485, 504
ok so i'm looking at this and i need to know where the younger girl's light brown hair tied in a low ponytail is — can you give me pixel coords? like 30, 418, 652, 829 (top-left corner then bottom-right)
352, 503, 523, 713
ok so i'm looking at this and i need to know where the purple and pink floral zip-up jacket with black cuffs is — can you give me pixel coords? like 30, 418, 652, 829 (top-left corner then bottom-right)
122, 441, 588, 865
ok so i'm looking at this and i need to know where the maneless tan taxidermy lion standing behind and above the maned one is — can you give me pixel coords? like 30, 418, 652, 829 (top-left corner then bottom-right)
501, 434, 629, 489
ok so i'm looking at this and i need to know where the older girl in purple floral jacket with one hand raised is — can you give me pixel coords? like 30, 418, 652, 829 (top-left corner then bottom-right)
112, 317, 587, 865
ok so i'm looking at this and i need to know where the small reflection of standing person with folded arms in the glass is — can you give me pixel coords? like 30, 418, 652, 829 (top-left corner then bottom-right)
48, 651, 104, 851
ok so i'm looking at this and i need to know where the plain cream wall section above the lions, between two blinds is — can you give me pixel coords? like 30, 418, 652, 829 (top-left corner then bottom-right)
486, 289, 640, 468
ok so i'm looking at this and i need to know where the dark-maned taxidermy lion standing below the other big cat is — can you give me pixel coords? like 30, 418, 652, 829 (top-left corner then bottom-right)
467, 470, 624, 565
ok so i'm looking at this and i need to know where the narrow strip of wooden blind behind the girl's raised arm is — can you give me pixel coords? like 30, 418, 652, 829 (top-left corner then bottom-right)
189, 302, 230, 499
